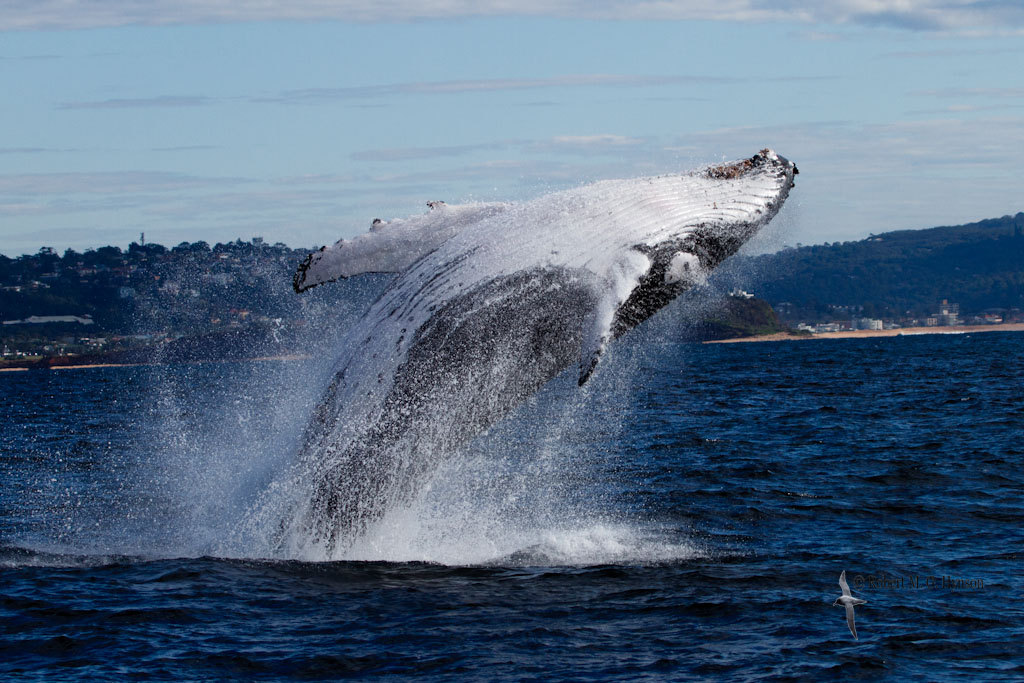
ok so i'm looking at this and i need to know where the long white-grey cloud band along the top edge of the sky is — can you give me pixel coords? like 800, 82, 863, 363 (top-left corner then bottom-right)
0, 0, 1024, 33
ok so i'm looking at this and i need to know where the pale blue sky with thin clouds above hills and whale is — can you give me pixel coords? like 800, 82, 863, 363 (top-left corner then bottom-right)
0, 0, 1024, 256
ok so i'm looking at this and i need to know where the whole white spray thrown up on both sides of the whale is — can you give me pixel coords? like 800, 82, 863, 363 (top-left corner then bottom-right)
10, 280, 733, 566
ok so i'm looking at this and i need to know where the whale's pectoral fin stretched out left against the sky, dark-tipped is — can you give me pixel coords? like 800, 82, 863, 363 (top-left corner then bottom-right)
292, 202, 506, 292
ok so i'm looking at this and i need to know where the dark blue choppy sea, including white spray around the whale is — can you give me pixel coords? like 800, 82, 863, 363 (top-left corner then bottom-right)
0, 334, 1024, 681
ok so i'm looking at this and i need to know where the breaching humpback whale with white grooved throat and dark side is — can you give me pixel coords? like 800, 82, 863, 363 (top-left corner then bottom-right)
278, 150, 798, 557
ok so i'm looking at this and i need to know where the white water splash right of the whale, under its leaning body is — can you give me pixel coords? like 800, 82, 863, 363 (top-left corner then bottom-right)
239, 337, 705, 566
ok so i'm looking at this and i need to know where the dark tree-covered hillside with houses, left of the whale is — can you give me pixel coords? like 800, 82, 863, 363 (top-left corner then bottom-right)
0, 238, 380, 358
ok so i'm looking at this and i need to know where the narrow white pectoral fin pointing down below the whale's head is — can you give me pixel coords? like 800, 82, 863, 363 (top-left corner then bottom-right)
580, 249, 650, 386
